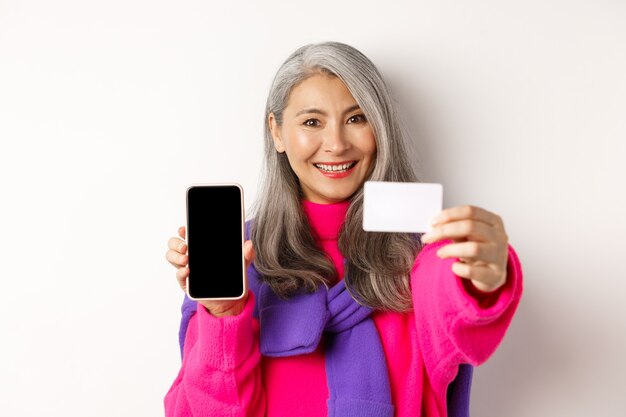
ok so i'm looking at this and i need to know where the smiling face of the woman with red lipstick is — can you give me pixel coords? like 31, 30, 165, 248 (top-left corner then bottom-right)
269, 74, 376, 204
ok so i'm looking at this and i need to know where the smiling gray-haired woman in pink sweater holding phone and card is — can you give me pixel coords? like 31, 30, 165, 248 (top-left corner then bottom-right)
164, 42, 522, 417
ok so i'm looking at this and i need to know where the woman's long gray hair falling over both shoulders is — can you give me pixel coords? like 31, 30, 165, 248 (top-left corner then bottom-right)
250, 42, 421, 311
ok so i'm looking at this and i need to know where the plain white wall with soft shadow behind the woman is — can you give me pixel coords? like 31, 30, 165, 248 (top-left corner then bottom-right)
0, 0, 626, 417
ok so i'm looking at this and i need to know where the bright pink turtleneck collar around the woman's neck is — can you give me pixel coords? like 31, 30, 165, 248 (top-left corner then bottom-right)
302, 199, 350, 240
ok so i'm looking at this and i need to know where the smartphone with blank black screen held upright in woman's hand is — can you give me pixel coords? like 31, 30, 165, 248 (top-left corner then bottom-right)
187, 183, 247, 300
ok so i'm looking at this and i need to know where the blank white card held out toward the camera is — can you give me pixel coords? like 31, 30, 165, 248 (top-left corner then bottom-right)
363, 181, 443, 233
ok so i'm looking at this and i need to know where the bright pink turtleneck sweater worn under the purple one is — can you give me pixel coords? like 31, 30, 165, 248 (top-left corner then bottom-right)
164, 201, 522, 417
